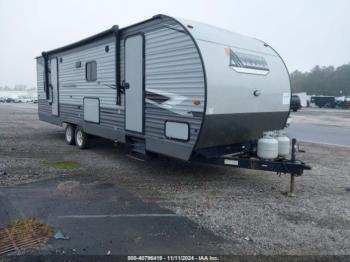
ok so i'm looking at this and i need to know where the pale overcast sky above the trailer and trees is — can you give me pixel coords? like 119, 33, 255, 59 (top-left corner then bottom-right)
0, 0, 350, 87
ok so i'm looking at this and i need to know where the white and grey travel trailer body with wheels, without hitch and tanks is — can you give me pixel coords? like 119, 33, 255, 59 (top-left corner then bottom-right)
37, 15, 308, 190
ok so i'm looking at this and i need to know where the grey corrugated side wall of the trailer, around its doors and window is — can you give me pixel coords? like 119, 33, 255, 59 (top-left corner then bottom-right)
37, 18, 205, 160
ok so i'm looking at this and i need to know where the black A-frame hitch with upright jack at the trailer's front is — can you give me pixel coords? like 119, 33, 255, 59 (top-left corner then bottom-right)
194, 138, 311, 196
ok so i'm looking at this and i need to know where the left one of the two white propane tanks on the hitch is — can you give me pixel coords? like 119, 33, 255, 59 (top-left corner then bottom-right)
257, 132, 278, 159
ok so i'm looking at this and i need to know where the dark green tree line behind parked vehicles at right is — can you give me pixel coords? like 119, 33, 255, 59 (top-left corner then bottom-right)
290, 63, 350, 96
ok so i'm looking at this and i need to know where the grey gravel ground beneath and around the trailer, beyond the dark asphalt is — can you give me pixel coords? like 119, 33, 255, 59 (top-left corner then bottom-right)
0, 104, 350, 255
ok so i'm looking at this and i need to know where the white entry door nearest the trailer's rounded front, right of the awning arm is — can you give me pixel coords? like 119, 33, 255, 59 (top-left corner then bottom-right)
124, 34, 144, 133
